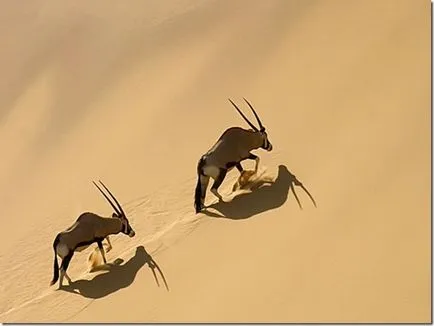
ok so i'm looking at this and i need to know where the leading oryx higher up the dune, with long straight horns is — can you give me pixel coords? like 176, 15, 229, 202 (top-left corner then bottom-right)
194, 99, 273, 213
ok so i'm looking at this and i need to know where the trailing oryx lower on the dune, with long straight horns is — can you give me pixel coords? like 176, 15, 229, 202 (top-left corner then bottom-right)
50, 181, 135, 288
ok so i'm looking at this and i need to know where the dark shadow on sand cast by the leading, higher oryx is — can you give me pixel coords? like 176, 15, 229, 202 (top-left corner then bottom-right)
203, 165, 316, 220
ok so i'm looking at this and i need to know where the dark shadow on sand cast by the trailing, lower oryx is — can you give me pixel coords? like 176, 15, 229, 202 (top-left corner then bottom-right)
61, 246, 169, 299
